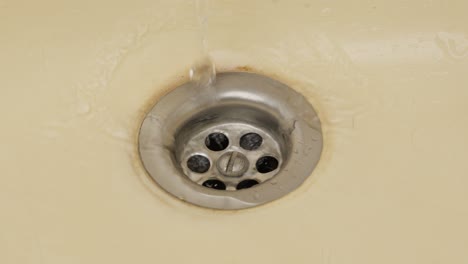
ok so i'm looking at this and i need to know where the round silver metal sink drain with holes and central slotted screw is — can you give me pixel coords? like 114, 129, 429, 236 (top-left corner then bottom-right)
139, 72, 322, 209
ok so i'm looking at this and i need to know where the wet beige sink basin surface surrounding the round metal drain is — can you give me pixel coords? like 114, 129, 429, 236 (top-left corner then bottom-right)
0, 0, 468, 264
